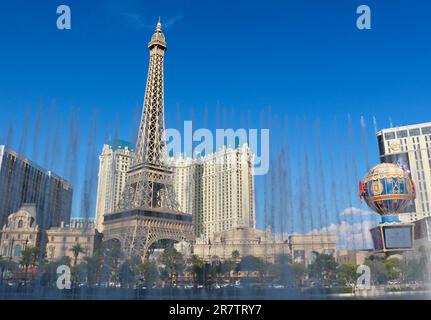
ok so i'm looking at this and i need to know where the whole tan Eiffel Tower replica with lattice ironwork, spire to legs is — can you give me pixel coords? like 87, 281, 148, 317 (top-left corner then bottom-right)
104, 19, 194, 258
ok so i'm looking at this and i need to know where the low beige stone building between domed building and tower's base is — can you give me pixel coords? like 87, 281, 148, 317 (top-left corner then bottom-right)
46, 219, 102, 263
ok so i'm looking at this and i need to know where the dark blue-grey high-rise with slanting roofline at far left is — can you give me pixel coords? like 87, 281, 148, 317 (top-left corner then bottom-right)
0, 146, 73, 229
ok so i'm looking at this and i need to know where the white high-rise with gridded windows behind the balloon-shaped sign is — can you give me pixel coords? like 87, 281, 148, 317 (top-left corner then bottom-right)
377, 122, 431, 222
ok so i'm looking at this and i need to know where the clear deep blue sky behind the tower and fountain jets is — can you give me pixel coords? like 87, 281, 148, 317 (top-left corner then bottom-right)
0, 0, 431, 249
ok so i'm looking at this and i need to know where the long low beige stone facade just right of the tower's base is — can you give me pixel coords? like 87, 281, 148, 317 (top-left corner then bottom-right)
193, 227, 336, 264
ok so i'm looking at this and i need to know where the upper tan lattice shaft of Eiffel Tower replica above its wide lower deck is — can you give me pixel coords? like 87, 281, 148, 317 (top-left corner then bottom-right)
117, 20, 178, 212
